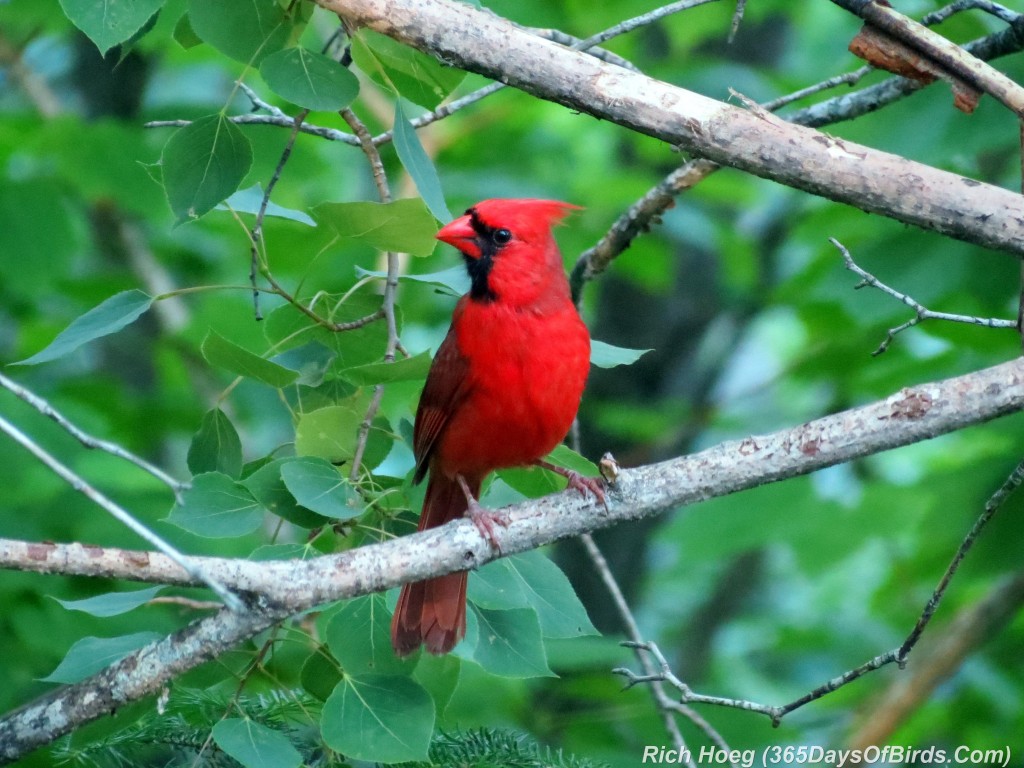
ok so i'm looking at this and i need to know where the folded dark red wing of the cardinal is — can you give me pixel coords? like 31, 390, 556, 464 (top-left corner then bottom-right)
413, 328, 469, 482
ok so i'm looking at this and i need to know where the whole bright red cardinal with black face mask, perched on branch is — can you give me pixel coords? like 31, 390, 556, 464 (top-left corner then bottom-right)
391, 200, 604, 656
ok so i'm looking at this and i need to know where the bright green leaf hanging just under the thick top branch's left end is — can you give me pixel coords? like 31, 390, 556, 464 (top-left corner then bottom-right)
352, 30, 466, 110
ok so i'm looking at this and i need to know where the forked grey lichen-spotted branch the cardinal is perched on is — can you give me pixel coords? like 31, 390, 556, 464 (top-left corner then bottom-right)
0, 358, 1024, 761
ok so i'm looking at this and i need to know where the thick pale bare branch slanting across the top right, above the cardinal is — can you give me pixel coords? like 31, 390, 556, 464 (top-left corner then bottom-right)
318, 0, 1024, 253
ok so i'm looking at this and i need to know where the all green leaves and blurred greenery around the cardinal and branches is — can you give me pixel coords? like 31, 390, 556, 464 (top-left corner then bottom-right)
0, 0, 1024, 766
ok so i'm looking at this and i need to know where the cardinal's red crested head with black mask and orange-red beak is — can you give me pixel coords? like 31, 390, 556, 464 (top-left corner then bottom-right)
437, 200, 580, 304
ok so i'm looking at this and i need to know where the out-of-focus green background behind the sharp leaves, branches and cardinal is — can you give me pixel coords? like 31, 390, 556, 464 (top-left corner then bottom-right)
0, 0, 1024, 766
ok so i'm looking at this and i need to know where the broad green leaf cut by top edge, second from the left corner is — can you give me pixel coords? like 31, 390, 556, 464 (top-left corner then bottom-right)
188, 0, 291, 64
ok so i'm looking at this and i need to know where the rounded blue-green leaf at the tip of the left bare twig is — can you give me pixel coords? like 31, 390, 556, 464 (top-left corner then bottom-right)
167, 472, 265, 539
